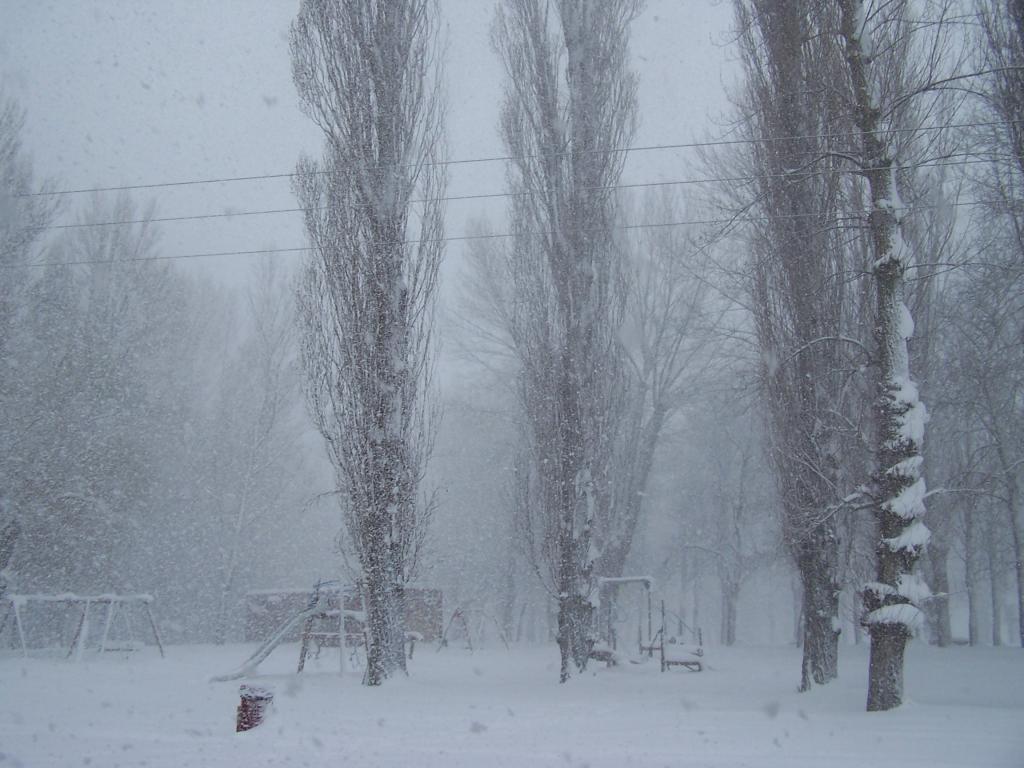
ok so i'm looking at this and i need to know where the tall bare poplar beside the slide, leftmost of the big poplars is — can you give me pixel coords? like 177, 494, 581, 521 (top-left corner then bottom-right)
291, 0, 444, 685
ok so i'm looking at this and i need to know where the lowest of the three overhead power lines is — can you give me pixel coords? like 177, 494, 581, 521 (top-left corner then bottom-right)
0, 200, 999, 269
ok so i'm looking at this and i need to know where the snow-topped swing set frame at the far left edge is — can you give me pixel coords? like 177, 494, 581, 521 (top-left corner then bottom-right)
0, 593, 164, 659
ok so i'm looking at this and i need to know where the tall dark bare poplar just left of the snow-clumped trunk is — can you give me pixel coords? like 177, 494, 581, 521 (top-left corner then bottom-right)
726, 0, 863, 690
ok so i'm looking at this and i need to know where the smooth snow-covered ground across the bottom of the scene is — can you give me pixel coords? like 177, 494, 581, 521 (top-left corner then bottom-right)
0, 644, 1024, 768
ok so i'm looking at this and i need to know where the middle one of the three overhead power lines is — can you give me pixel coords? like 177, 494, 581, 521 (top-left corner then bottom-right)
26, 153, 989, 231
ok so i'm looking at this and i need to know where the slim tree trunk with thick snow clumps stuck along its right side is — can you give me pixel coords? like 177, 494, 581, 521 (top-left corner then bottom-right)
840, 0, 929, 711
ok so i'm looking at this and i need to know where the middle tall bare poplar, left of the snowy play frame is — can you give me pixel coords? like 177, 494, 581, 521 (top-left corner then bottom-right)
494, 0, 638, 682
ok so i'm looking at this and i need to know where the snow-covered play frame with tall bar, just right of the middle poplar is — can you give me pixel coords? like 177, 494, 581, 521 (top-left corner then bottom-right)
590, 577, 703, 672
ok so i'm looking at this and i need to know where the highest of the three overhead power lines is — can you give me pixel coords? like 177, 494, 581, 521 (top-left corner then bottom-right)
15, 120, 1021, 198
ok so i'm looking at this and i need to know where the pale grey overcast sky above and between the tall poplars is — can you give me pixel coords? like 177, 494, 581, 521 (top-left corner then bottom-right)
0, 0, 734, 360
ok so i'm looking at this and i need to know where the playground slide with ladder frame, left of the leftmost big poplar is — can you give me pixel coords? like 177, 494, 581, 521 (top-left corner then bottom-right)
210, 581, 367, 683
